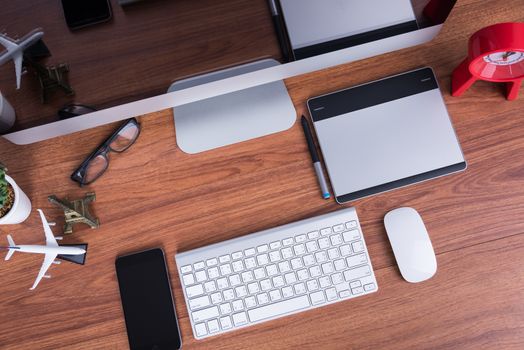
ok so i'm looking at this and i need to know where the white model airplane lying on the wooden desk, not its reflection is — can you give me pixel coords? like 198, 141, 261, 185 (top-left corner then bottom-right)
5, 209, 86, 290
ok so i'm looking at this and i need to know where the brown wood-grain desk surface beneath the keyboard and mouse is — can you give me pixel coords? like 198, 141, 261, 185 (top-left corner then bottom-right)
0, 0, 524, 349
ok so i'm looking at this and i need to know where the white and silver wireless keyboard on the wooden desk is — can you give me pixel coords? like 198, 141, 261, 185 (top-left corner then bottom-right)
175, 208, 377, 339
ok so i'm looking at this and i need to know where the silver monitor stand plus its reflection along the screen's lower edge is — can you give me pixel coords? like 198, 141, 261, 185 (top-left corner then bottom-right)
168, 59, 296, 154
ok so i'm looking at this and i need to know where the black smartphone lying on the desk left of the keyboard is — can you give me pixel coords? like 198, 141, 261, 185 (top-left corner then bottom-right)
115, 248, 182, 350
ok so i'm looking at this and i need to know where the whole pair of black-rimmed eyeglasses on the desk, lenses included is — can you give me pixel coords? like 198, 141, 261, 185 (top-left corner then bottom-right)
71, 118, 140, 186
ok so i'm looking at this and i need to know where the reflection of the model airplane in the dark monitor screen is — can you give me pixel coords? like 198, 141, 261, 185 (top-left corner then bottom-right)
0, 28, 44, 89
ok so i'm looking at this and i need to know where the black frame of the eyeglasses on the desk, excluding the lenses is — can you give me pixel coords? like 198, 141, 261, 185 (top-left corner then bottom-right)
71, 118, 141, 187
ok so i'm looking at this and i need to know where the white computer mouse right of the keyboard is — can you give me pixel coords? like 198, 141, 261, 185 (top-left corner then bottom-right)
384, 207, 437, 283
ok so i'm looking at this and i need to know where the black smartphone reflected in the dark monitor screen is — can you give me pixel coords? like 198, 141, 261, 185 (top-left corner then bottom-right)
62, 0, 111, 29
